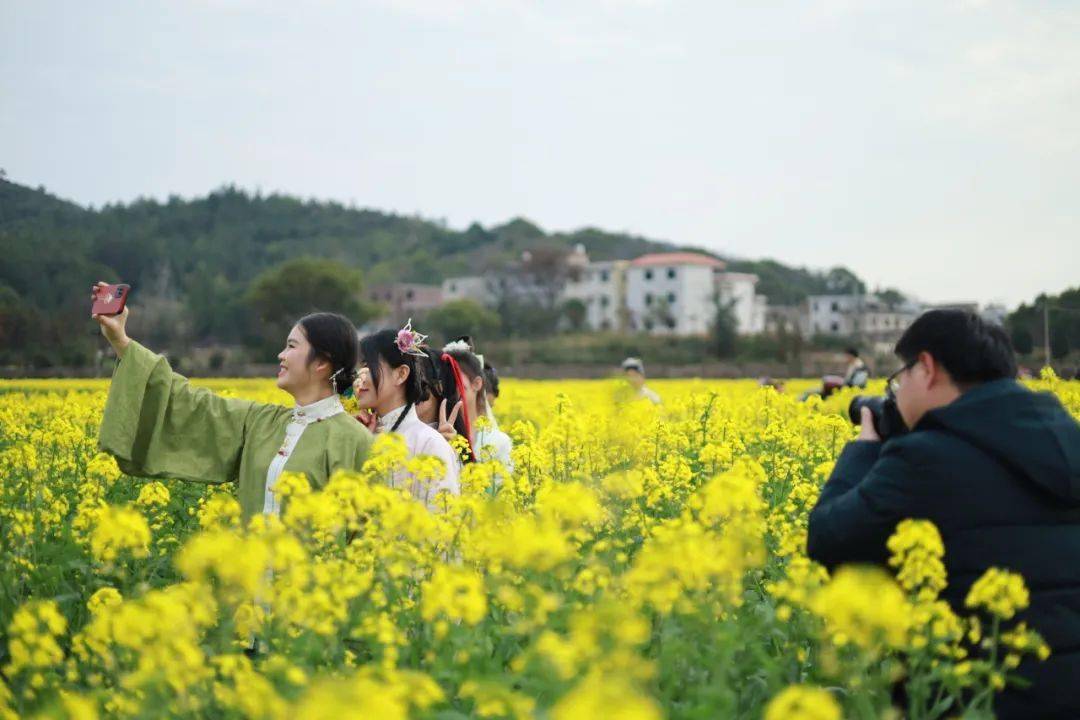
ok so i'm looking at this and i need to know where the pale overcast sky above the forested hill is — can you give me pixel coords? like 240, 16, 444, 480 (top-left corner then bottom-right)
0, 0, 1080, 305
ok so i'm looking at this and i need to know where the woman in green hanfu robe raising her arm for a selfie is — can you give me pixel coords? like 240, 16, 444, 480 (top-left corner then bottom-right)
93, 283, 372, 520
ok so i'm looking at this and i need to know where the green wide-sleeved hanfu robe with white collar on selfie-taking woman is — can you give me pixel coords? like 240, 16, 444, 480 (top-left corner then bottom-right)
98, 342, 372, 520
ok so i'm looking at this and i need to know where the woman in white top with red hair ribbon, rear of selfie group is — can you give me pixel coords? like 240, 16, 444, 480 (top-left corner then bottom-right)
438, 338, 514, 473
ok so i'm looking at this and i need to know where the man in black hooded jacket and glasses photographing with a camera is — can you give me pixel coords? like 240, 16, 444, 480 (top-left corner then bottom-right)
807, 310, 1080, 718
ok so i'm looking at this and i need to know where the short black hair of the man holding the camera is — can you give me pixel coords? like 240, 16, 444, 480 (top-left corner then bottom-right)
894, 310, 1016, 386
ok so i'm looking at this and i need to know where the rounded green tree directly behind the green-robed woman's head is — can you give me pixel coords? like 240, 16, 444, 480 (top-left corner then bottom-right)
246, 257, 373, 351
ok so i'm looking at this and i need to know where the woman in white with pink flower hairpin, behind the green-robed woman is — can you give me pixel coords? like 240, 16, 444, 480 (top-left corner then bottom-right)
353, 321, 461, 510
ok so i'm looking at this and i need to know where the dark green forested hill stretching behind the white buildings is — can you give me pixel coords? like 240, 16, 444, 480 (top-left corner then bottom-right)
0, 179, 859, 365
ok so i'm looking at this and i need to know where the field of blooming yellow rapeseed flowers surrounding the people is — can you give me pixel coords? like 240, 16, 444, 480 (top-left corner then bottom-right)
0, 377, 1080, 720
